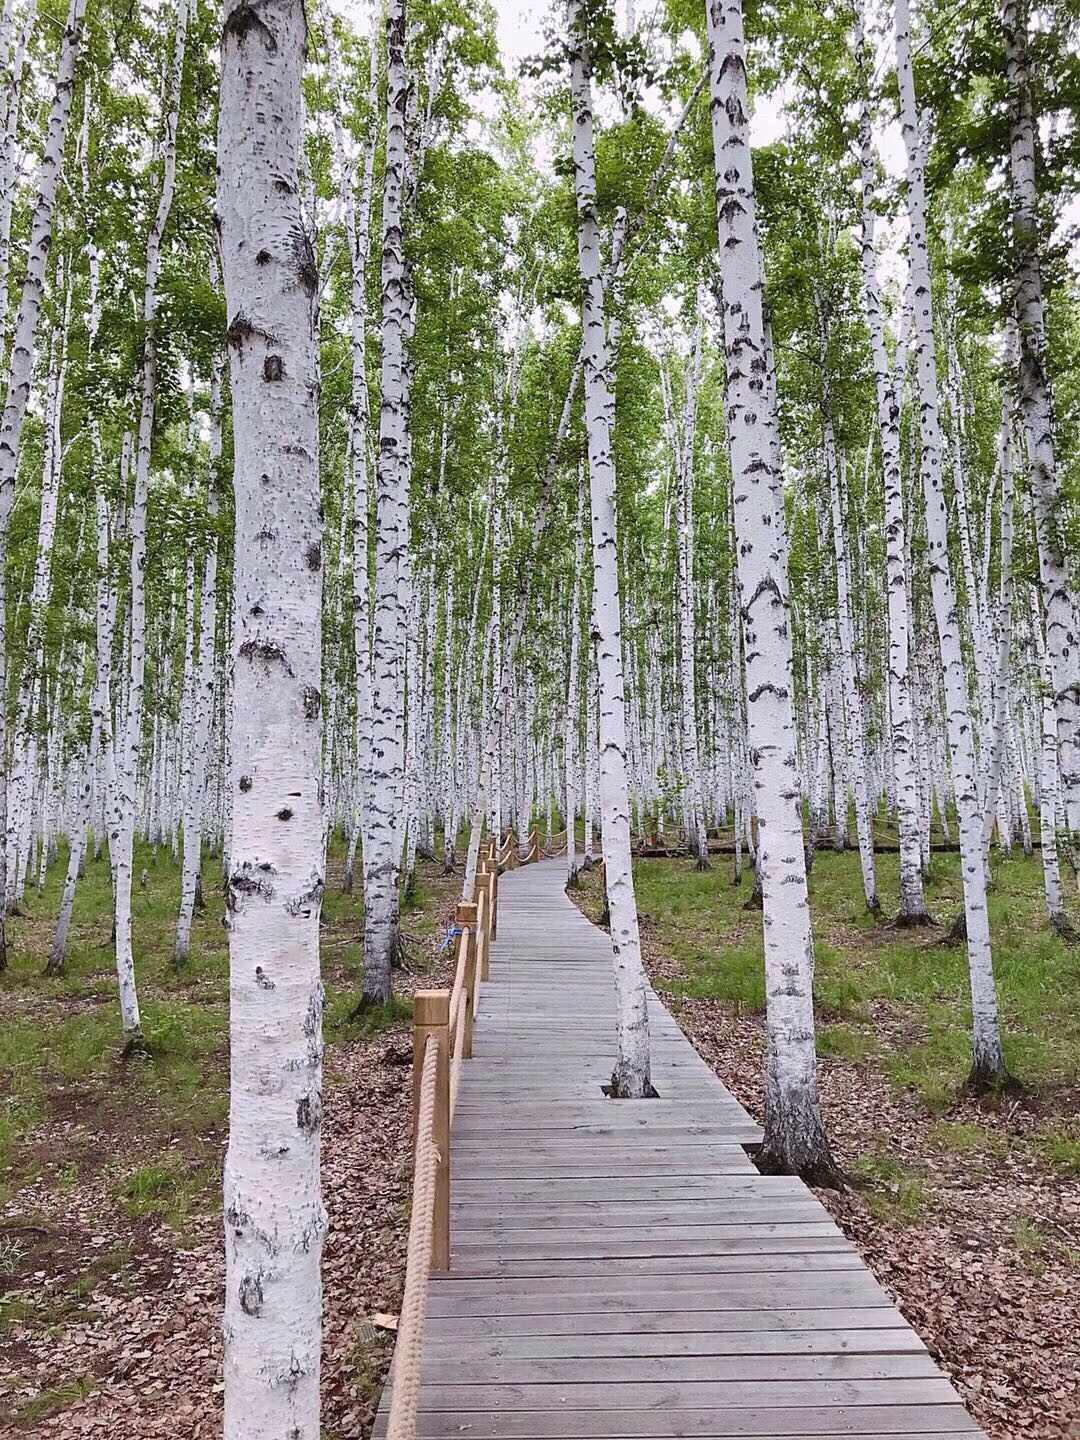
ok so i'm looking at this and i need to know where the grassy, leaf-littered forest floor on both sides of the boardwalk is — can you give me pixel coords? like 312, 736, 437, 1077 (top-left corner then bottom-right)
0, 850, 1080, 1440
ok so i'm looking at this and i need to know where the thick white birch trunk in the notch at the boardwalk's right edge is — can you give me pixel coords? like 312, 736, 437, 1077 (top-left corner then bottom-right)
706, 0, 838, 1184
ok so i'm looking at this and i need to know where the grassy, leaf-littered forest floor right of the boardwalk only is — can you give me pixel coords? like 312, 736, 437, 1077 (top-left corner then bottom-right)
576, 851, 1080, 1440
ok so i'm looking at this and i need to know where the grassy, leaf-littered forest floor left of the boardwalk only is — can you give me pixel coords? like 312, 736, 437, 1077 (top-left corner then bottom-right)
0, 848, 461, 1440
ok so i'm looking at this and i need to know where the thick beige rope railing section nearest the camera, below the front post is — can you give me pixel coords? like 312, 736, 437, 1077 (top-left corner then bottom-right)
386, 1035, 441, 1440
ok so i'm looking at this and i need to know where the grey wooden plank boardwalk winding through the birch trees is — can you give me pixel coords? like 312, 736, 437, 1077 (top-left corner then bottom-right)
374, 861, 981, 1440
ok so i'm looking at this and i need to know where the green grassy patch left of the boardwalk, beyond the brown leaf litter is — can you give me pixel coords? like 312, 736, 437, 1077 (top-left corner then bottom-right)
0, 841, 459, 1209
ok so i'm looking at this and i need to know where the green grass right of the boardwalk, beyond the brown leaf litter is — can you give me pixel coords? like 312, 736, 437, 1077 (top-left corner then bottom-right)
635, 850, 1080, 1123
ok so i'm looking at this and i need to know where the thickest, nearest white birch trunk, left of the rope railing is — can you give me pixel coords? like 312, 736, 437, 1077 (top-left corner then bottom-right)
217, 0, 325, 1422
